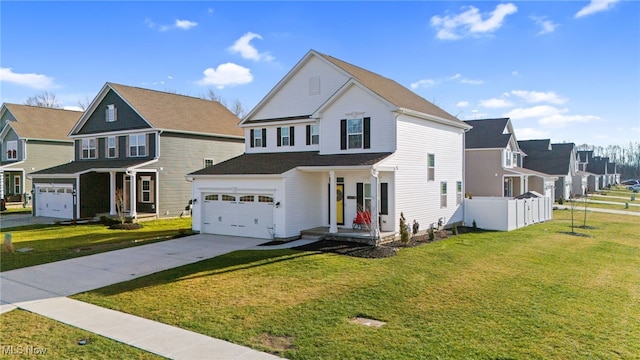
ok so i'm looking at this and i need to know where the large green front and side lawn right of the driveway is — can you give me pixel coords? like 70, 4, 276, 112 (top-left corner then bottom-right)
74, 210, 640, 359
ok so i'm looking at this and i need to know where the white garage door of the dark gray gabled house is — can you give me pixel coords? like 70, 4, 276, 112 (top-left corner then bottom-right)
35, 186, 73, 219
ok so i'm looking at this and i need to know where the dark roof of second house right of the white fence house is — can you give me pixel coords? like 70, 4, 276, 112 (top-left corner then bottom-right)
519, 140, 575, 175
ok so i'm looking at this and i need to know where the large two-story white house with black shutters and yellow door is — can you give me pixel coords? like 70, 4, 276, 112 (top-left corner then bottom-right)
187, 50, 470, 239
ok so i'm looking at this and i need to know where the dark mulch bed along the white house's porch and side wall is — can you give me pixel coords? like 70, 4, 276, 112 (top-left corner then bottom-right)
294, 227, 468, 259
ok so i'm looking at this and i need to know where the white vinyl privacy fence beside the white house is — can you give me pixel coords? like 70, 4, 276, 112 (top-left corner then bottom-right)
464, 196, 553, 231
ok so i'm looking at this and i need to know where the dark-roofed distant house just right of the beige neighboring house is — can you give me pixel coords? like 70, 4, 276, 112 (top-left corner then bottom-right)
518, 139, 577, 200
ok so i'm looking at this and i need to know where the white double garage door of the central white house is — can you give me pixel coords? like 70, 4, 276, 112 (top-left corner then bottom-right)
202, 193, 273, 239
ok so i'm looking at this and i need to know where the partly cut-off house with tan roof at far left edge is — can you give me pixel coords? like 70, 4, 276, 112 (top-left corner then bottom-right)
0, 104, 82, 204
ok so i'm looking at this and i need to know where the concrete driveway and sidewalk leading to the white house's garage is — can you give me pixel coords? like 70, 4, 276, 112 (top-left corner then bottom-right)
0, 235, 309, 359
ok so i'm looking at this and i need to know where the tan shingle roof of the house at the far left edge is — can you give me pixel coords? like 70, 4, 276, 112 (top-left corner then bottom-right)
2, 104, 82, 142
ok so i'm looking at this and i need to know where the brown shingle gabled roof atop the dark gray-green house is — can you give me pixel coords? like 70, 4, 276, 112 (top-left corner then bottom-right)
71, 83, 244, 137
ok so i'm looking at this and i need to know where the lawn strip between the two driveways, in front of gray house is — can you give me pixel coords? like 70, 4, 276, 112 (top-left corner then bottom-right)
0, 218, 191, 271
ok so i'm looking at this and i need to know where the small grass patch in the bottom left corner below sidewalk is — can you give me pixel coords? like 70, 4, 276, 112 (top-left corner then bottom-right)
0, 310, 164, 359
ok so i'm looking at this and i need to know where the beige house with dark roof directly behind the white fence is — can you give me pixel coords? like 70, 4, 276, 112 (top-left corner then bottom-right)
465, 118, 556, 198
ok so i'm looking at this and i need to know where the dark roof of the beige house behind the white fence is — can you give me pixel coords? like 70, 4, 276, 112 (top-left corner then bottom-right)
464, 118, 513, 149
